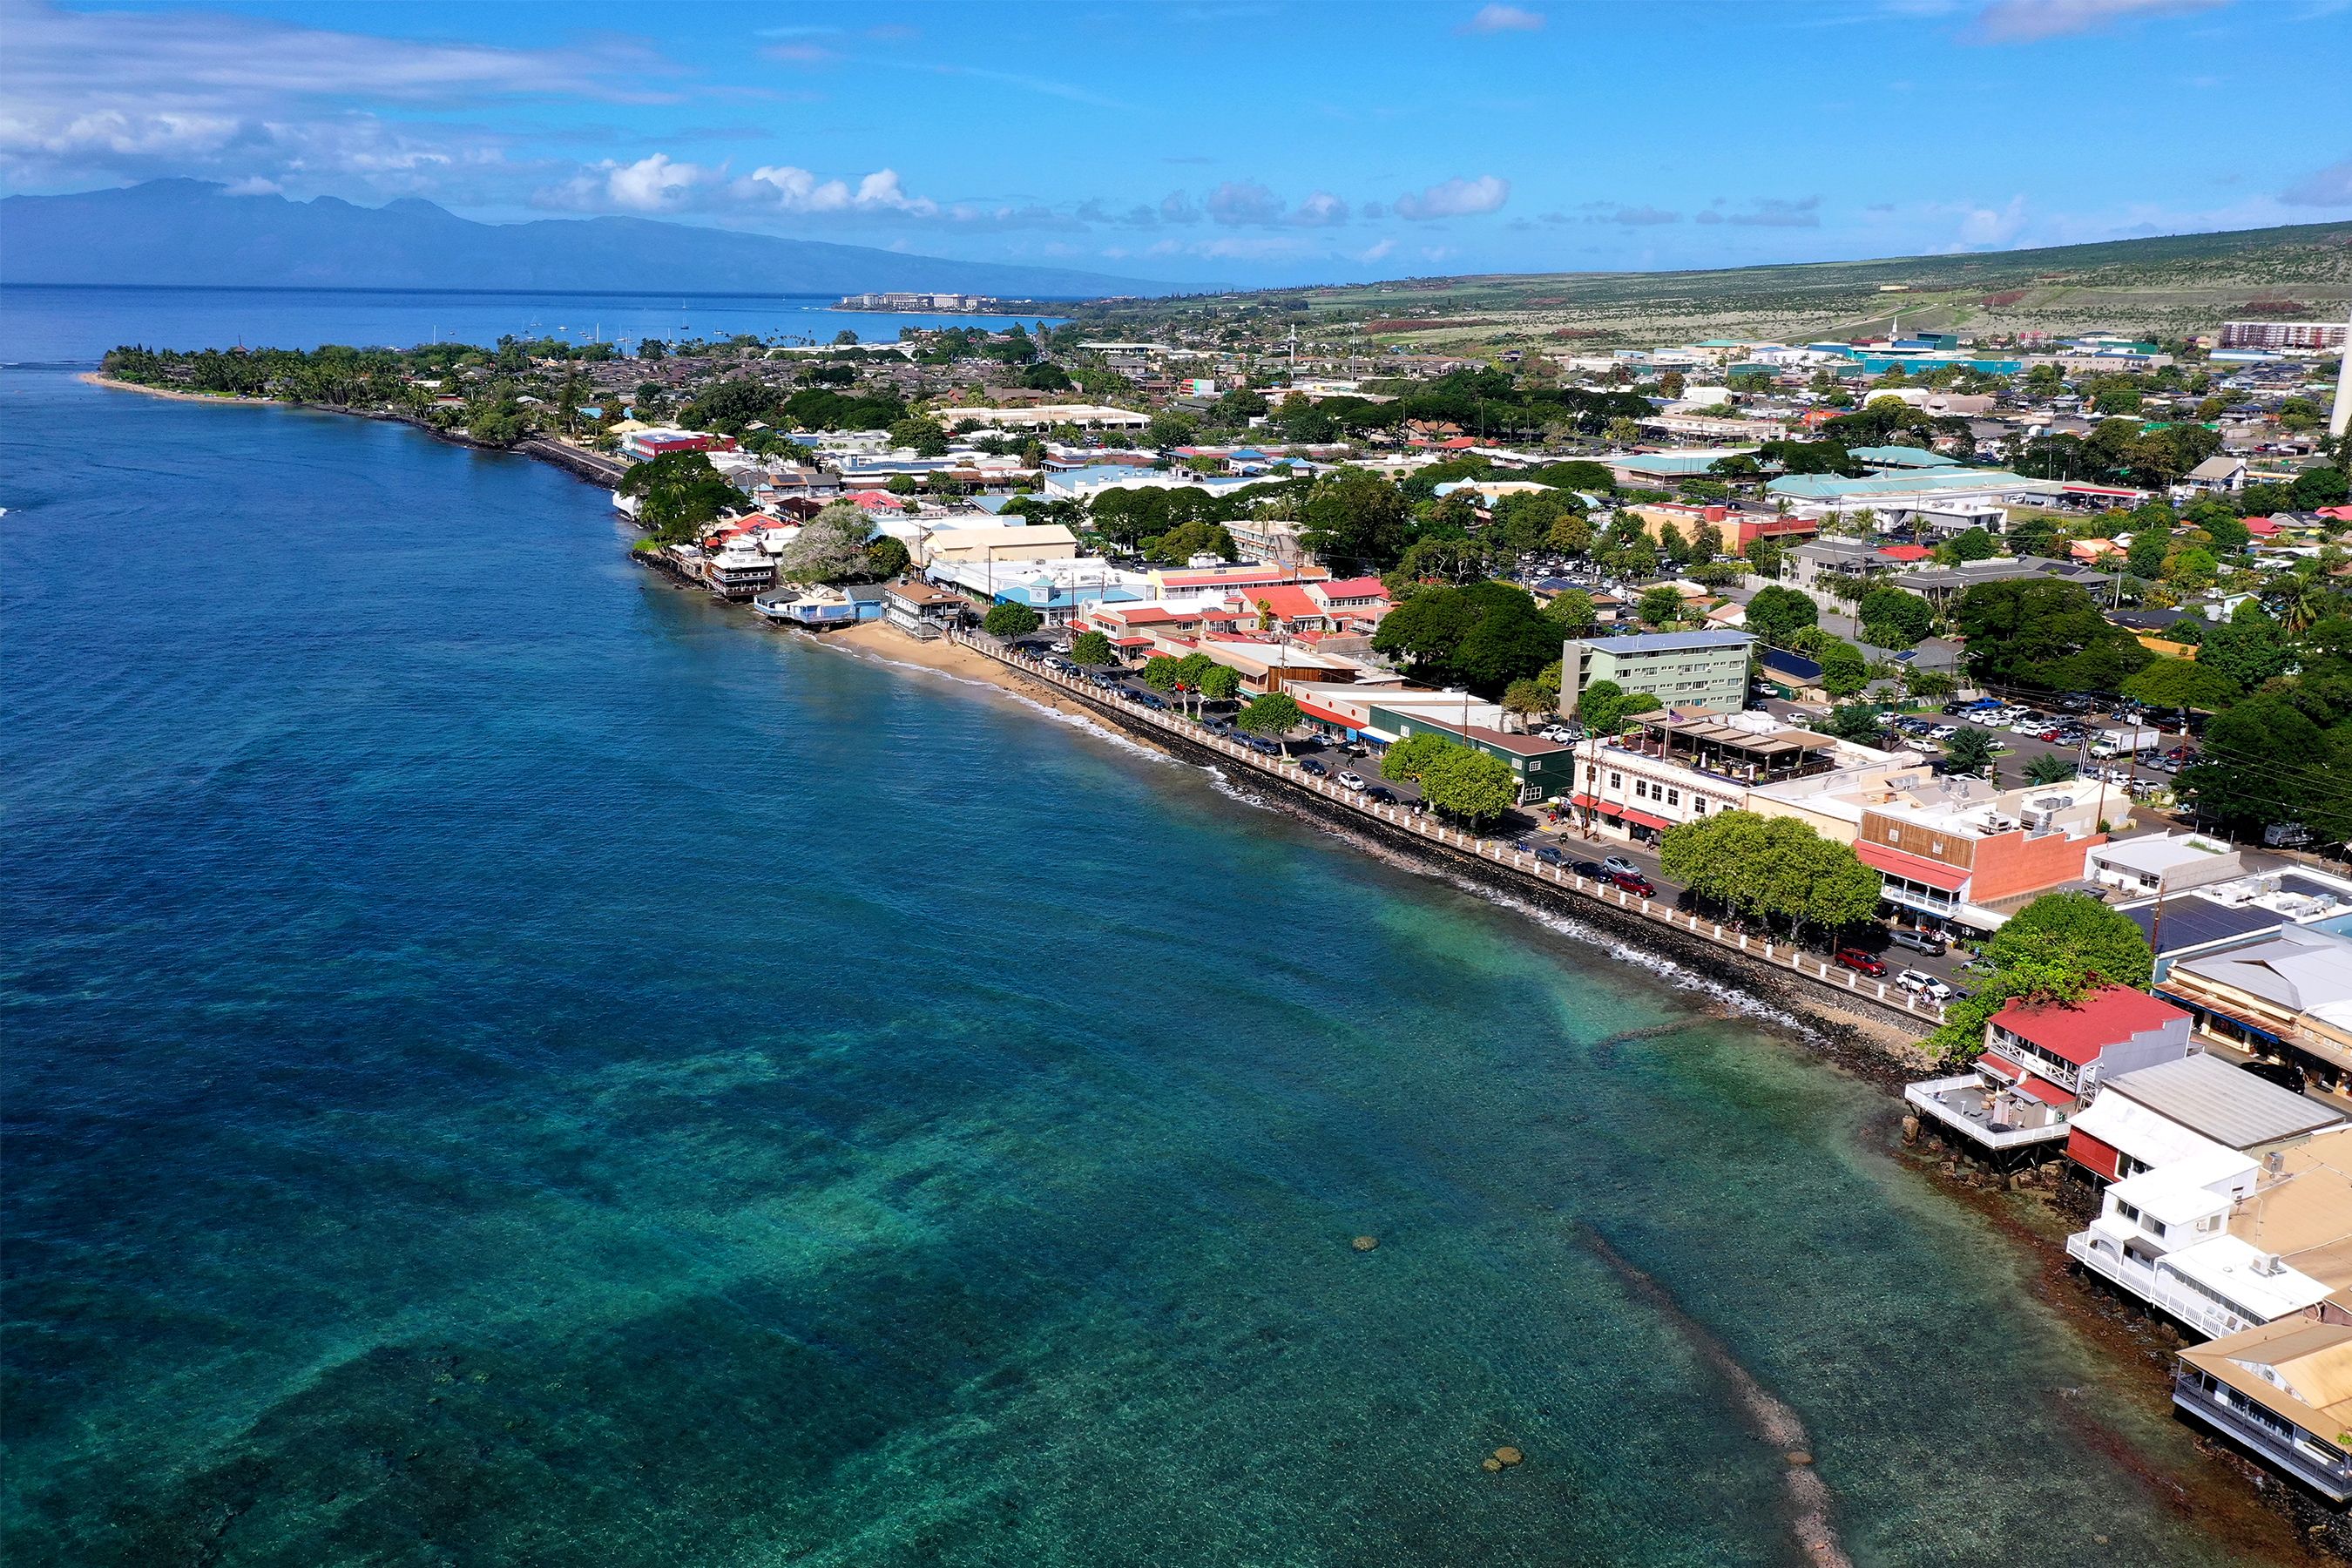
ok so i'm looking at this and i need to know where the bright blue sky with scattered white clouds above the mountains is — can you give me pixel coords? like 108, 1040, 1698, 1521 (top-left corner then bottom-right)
0, 0, 2352, 282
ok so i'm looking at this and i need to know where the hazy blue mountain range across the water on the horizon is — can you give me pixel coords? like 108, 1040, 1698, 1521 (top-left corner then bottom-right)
0, 179, 1173, 299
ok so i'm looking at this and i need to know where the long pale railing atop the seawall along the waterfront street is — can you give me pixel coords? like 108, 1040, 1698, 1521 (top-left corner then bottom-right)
948, 628, 1943, 1025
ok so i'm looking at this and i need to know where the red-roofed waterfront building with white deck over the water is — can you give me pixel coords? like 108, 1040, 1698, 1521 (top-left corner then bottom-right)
1903, 985, 2200, 1159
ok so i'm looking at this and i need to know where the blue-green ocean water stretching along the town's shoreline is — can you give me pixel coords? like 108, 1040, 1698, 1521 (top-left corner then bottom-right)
0, 292, 2286, 1568
